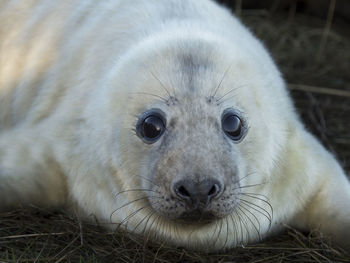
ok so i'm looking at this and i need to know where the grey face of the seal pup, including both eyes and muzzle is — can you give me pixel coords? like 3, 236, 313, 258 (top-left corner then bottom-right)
136, 105, 247, 222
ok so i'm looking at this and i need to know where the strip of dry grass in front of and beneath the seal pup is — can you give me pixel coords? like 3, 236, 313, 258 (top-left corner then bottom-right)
0, 209, 350, 262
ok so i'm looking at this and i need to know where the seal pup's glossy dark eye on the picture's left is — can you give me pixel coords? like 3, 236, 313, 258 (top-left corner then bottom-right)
136, 110, 165, 144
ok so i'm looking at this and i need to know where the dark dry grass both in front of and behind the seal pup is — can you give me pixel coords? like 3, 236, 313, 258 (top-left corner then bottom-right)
0, 4, 350, 262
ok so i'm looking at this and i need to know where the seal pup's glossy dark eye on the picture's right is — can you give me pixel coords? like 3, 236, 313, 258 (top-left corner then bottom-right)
221, 110, 243, 141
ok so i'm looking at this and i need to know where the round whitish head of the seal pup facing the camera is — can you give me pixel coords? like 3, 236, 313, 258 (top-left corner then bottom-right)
103, 32, 291, 250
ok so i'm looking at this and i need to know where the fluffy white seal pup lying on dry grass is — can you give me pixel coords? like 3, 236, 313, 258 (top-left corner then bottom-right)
0, 0, 350, 250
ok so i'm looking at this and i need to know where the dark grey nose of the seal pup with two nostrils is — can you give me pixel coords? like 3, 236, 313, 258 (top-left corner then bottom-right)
172, 179, 223, 208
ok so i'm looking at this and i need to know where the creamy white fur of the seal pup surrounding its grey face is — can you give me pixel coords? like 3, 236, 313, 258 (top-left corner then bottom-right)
0, 0, 350, 253
